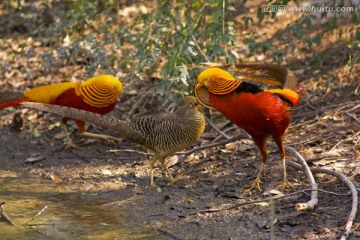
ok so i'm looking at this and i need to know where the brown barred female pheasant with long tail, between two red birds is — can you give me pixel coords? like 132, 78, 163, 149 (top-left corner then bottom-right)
23, 97, 205, 187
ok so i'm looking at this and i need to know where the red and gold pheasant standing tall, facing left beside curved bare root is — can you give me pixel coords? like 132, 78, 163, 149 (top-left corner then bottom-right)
194, 63, 300, 191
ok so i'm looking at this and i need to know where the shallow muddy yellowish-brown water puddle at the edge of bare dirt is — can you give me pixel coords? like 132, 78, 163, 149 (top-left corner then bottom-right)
0, 171, 166, 239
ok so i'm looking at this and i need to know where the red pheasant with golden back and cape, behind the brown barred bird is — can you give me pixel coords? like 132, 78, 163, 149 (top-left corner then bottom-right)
0, 75, 122, 146
